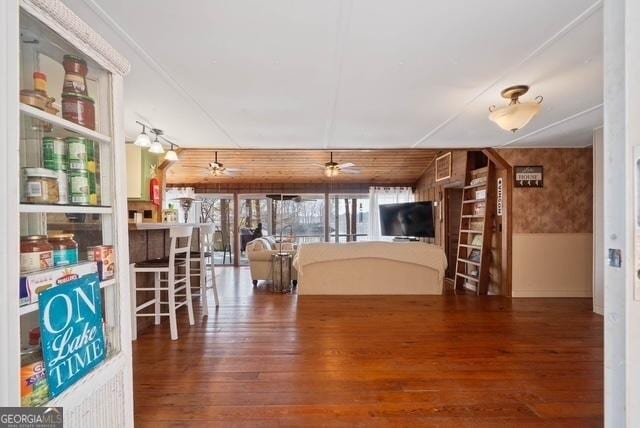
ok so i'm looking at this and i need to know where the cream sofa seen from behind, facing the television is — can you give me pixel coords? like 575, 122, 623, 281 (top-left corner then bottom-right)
294, 242, 447, 295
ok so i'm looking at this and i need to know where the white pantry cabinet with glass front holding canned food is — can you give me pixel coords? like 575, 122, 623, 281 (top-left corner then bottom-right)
0, 0, 133, 427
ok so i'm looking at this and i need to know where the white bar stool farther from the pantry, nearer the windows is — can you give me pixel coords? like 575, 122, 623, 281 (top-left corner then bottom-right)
179, 223, 220, 315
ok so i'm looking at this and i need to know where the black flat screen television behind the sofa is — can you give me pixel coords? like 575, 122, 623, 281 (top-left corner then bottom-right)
380, 201, 435, 238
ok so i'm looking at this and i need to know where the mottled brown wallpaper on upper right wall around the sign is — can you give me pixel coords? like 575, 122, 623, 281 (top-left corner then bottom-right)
498, 147, 593, 233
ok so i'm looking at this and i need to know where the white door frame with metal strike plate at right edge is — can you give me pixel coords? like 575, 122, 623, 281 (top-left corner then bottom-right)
603, 0, 640, 428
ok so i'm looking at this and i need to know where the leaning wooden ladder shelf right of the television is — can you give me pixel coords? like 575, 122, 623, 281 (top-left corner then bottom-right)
454, 155, 495, 295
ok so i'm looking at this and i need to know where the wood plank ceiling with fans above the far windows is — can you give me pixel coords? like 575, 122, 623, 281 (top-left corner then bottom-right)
167, 149, 438, 185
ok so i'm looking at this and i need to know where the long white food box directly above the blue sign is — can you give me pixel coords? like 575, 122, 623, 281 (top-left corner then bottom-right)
20, 262, 98, 305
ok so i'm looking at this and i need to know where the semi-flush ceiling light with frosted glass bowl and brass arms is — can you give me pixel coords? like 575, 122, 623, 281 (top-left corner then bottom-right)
489, 85, 542, 132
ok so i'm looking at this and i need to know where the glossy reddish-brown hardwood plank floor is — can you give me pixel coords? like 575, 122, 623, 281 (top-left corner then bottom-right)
133, 268, 603, 428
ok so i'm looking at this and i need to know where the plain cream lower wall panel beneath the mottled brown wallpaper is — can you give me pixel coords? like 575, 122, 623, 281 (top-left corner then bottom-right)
512, 233, 593, 297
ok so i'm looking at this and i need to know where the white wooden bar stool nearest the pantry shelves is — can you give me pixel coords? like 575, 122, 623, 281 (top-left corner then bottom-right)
129, 226, 195, 340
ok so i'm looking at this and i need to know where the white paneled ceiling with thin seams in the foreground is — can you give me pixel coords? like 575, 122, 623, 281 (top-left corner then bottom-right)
65, 0, 603, 149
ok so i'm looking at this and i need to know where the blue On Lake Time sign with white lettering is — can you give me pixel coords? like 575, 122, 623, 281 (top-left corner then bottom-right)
38, 273, 106, 398
